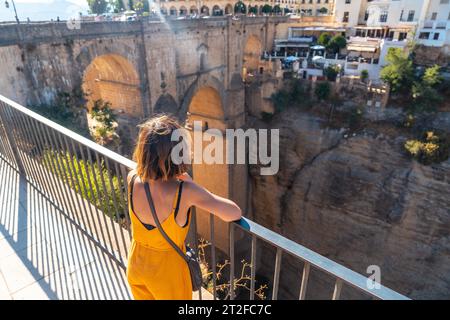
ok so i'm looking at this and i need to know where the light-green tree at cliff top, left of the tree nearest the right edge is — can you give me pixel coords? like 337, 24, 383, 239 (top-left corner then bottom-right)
380, 48, 414, 92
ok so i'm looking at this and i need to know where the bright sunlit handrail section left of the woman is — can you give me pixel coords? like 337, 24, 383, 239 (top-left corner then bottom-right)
0, 94, 136, 169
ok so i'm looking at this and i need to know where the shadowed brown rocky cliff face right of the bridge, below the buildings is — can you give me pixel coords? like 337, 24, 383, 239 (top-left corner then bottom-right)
251, 110, 450, 299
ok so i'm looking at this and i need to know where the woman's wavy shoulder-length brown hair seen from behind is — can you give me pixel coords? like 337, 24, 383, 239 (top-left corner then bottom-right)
133, 114, 187, 181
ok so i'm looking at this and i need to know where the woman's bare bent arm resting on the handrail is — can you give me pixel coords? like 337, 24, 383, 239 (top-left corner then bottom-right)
183, 181, 242, 222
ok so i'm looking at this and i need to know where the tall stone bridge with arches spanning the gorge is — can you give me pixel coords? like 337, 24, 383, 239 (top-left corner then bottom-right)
0, 17, 286, 248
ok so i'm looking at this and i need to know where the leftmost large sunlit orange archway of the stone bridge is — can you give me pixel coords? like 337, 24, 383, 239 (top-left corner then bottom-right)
82, 54, 144, 117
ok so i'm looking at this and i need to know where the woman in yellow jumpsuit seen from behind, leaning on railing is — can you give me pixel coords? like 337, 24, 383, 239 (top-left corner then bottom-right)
127, 115, 241, 300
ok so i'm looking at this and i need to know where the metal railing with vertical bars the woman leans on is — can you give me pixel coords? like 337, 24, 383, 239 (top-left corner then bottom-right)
0, 95, 408, 300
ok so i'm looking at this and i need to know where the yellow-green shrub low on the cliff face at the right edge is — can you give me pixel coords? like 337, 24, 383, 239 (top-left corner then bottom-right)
404, 131, 449, 165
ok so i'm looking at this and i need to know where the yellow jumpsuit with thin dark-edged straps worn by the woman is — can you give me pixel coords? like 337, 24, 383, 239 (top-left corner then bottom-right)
127, 179, 192, 300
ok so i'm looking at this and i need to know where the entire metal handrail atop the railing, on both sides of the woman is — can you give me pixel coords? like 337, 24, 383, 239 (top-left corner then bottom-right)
0, 95, 409, 300
